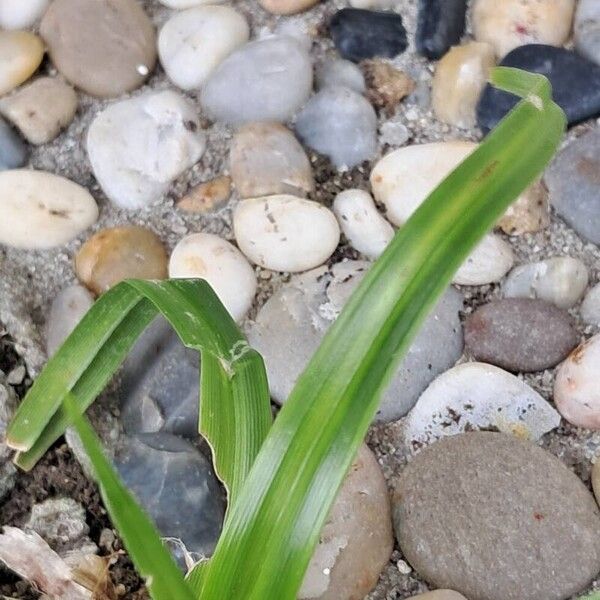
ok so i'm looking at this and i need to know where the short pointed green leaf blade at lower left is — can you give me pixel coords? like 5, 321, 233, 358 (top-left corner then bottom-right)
64, 394, 195, 600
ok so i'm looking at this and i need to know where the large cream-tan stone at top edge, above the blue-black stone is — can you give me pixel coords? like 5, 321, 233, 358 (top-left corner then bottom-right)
472, 0, 575, 58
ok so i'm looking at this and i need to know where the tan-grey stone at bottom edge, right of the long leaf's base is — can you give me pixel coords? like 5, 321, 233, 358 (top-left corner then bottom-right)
298, 445, 394, 600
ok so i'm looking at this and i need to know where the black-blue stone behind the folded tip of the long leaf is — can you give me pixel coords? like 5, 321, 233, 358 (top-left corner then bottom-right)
477, 44, 600, 131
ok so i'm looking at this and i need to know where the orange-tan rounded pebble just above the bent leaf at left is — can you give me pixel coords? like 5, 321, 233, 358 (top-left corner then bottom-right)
75, 226, 167, 294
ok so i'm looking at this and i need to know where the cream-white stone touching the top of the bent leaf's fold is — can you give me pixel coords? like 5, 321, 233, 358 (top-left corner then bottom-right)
169, 233, 257, 321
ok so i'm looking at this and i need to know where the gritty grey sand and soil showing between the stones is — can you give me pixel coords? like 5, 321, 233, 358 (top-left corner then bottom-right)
0, 0, 600, 600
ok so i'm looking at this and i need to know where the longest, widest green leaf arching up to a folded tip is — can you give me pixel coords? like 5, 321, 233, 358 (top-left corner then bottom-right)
189, 69, 566, 600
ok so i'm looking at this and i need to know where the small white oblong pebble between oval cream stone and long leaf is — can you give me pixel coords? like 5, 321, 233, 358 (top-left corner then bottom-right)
333, 190, 394, 260
